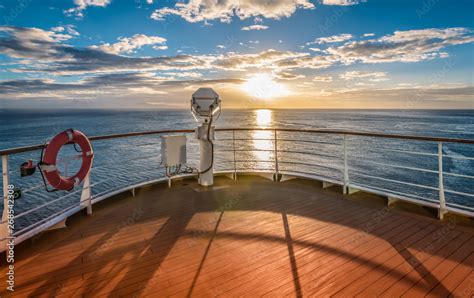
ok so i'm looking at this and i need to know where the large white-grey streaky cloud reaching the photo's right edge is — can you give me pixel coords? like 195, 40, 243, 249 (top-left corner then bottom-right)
327, 28, 474, 64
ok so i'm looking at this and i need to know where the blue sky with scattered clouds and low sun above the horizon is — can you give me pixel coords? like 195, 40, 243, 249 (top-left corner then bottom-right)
0, 0, 474, 109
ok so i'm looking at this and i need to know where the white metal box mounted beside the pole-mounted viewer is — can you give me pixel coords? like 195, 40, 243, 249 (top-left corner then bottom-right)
161, 135, 186, 167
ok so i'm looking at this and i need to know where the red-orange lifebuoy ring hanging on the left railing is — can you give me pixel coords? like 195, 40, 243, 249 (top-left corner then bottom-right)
41, 129, 94, 190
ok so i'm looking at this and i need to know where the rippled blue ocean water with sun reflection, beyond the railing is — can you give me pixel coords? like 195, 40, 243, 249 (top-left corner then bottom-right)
0, 110, 474, 231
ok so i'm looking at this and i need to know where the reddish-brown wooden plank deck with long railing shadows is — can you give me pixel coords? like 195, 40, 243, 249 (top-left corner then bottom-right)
0, 177, 474, 297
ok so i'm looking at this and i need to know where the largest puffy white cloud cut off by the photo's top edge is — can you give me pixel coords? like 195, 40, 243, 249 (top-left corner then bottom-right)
151, 0, 315, 23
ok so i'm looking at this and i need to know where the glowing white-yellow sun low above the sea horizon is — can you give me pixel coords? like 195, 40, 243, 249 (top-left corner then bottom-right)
242, 73, 290, 99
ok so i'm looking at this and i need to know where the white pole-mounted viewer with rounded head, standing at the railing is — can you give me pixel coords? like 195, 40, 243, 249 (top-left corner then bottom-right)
191, 88, 221, 186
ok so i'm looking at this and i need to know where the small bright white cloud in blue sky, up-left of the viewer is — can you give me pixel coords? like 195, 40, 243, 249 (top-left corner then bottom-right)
91, 34, 166, 55
